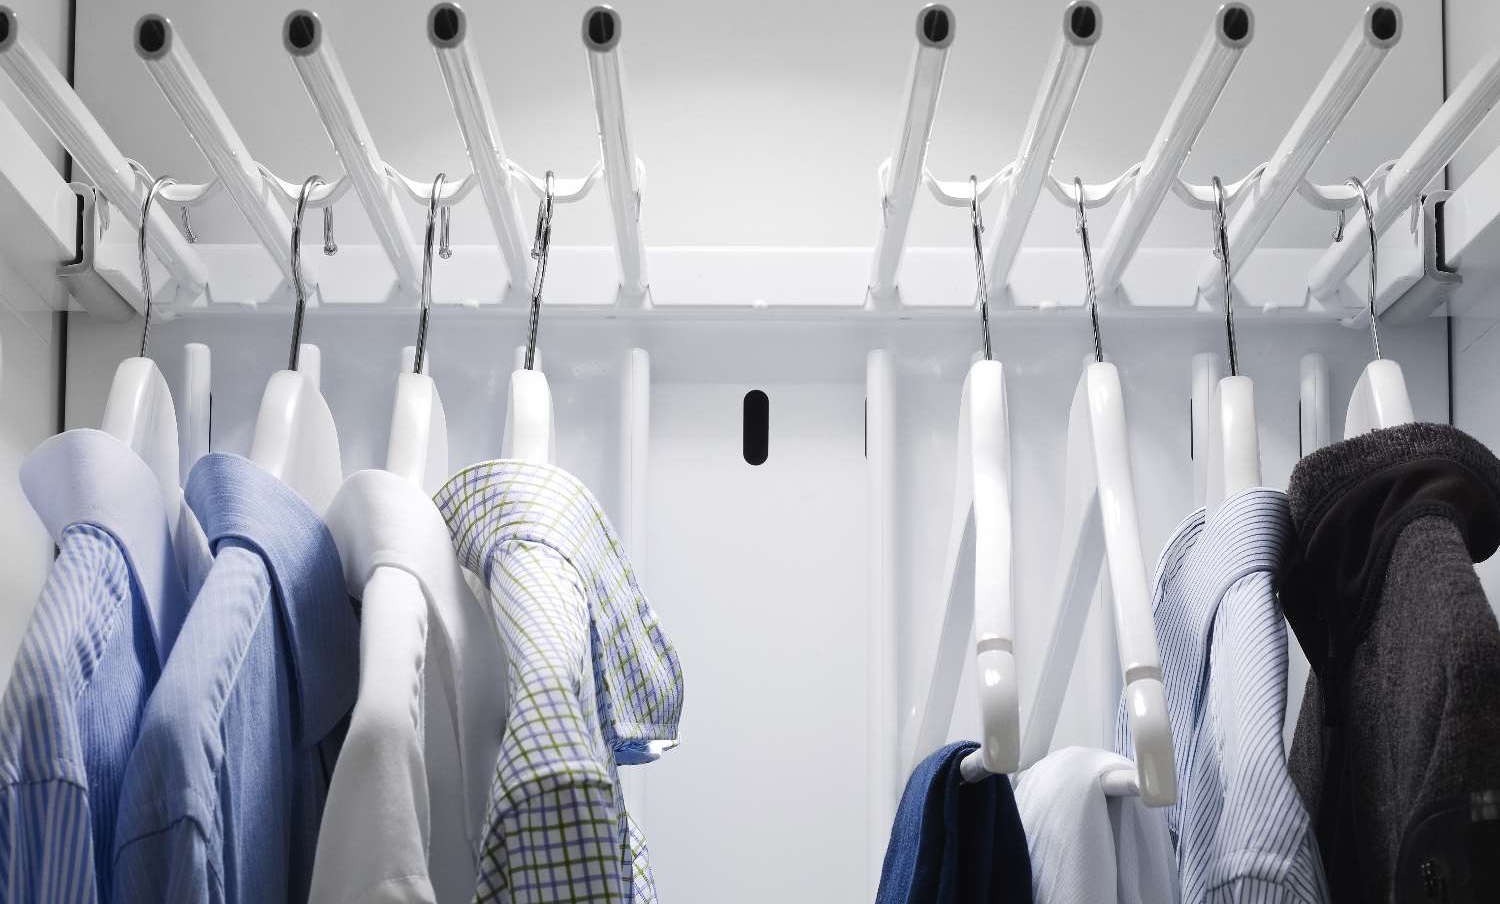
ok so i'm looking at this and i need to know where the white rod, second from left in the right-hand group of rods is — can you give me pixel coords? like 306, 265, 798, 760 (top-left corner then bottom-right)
986, 0, 1104, 298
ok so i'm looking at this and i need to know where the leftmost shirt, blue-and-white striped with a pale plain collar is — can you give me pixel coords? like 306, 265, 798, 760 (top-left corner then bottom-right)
0, 430, 186, 904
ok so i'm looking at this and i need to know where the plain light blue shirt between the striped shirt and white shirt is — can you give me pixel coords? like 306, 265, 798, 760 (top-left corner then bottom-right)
113, 454, 357, 904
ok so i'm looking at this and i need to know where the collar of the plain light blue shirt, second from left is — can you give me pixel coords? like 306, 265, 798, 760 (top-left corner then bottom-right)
186, 453, 359, 744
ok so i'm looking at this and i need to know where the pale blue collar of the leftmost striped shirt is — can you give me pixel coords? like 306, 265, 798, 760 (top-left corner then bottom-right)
20, 429, 188, 663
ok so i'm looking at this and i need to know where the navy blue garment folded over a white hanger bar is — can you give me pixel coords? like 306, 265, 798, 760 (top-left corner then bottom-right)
875, 741, 1032, 904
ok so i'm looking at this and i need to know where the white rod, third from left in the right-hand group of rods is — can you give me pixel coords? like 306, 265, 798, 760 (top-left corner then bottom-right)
1098, 3, 1256, 304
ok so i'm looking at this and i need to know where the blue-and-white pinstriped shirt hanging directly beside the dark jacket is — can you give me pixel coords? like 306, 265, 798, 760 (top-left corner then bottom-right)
1115, 487, 1328, 904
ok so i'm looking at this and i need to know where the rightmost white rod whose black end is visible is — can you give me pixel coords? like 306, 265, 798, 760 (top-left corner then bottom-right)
1199, 1, 1401, 292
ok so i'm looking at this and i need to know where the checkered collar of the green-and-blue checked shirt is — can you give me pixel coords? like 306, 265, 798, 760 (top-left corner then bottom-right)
437, 459, 683, 763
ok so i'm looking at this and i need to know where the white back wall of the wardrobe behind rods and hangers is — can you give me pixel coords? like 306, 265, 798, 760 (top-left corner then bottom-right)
55, 0, 1448, 904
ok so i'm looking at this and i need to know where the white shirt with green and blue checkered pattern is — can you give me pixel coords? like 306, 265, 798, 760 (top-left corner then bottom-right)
437, 460, 683, 904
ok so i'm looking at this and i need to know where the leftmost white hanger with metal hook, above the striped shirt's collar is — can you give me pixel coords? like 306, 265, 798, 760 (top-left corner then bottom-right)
99, 175, 183, 531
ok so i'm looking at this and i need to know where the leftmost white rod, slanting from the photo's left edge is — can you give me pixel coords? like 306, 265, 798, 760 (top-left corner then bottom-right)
0, 6, 209, 291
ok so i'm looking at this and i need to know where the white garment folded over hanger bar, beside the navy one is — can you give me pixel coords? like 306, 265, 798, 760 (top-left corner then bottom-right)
1016, 747, 1179, 904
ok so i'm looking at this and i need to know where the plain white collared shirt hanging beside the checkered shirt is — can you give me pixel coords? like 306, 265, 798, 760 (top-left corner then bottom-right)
309, 471, 506, 904
